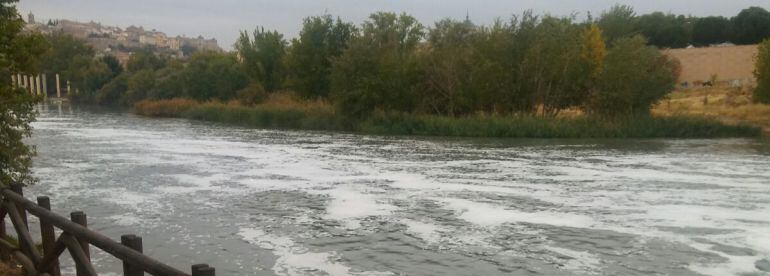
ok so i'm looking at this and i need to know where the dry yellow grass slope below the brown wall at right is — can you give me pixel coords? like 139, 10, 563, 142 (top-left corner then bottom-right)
652, 87, 770, 136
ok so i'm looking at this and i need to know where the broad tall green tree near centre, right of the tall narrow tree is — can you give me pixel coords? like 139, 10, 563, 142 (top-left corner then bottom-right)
332, 12, 424, 119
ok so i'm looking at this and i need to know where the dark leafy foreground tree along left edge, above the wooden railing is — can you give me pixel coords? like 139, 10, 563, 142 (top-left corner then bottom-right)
0, 0, 47, 186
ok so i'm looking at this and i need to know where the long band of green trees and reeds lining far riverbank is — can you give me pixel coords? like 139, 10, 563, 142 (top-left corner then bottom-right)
37, 6, 770, 138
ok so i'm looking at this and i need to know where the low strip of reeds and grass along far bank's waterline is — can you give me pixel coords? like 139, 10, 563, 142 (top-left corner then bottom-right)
134, 98, 761, 138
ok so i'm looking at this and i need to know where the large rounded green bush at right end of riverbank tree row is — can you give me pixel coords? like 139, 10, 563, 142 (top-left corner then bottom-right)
586, 36, 679, 117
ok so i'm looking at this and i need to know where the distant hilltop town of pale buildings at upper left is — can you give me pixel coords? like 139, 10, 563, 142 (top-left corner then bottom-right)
25, 12, 222, 64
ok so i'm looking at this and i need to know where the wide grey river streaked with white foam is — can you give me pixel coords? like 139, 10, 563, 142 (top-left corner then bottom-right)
26, 102, 770, 275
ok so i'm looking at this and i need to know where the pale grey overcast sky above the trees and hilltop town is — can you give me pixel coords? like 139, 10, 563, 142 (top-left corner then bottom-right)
17, 0, 770, 49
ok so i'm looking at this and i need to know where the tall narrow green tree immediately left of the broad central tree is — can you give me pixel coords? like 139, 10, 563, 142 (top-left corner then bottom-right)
286, 15, 356, 99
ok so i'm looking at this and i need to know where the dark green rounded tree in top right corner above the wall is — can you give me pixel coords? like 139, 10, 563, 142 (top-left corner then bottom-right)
732, 7, 770, 44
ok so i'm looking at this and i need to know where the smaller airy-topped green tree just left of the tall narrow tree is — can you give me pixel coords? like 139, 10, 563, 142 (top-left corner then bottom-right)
235, 28, 287, 92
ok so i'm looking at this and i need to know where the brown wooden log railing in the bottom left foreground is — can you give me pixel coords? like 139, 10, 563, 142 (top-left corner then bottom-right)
0, 186, 215, 276
